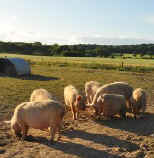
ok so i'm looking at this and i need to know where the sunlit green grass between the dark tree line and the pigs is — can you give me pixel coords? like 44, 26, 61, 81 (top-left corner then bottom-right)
0, 54, 154, 110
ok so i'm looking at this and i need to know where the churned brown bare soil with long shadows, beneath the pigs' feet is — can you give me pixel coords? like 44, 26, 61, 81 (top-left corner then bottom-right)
0, 106, 154, 158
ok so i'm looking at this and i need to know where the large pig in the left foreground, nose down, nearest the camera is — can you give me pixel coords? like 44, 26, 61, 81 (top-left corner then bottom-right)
6, 100, 65, 142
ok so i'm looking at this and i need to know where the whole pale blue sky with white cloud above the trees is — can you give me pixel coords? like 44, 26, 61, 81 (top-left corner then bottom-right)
0, 0, 154, 45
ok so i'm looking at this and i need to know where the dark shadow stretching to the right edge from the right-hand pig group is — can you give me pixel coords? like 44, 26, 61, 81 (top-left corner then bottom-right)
95, 113, 154, 136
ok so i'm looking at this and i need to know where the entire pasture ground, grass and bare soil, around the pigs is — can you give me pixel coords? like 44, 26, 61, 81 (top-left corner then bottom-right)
0, 54, 154, 158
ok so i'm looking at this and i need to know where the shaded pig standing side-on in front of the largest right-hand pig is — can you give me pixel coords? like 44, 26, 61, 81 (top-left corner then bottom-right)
94, 93, 126, 119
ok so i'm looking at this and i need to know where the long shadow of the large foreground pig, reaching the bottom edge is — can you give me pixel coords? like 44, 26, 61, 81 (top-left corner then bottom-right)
25, 137, 120, 158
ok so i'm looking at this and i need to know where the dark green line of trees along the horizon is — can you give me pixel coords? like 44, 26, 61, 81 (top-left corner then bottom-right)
0, 41, 154, 58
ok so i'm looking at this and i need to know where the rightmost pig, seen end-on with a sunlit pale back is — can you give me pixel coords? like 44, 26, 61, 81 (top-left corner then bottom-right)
130, 88, 147, 119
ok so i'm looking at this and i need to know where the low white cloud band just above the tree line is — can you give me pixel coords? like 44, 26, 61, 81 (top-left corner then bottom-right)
0, 30, 154, 45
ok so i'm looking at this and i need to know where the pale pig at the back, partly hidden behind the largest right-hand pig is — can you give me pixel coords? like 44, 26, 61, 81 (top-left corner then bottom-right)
85, 81, 101, 105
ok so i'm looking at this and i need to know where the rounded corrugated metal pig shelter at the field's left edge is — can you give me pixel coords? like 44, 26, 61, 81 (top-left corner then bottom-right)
0, 58, 31, 76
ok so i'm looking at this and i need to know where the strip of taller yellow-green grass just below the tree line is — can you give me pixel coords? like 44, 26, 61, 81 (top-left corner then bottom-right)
0, 53, 154, 72
